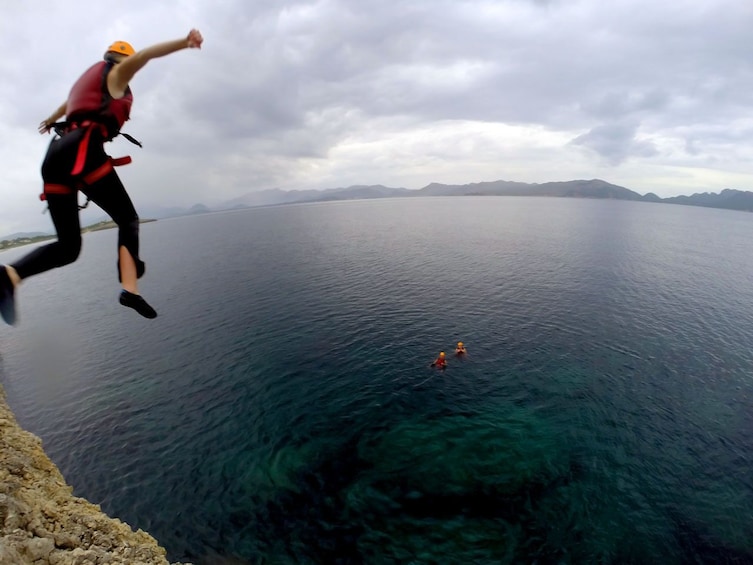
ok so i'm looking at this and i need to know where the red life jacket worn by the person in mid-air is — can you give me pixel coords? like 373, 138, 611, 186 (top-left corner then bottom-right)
65, 61, 133, 141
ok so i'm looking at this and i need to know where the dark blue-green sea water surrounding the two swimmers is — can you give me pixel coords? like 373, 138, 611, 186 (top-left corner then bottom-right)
0, 198, 753, 564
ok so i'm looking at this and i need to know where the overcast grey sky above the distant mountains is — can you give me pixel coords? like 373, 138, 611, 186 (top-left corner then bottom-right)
0, 0, 753, 234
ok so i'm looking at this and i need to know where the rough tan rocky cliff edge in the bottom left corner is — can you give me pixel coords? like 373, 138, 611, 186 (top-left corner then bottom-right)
0, 387, 187, 565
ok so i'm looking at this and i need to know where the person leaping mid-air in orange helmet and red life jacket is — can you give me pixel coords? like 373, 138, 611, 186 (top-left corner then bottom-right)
0, 29, 204, 325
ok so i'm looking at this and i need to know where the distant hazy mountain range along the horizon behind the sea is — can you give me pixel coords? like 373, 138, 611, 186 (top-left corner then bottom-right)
5, 179, 753, 239
